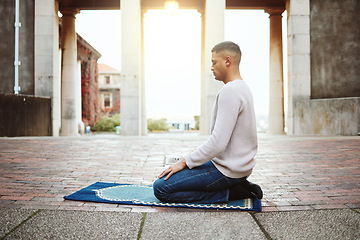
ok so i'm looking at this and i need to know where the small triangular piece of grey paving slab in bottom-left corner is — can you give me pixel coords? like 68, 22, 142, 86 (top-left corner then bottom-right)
0, 208, 36, 238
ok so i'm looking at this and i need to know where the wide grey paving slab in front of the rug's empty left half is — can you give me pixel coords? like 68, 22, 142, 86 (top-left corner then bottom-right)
7, 210, 142, 239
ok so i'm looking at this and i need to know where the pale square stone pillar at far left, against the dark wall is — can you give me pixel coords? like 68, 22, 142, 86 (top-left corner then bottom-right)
34, 0, 61, 136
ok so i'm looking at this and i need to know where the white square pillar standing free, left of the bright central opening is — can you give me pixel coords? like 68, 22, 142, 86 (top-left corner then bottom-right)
120, 0, 142, 135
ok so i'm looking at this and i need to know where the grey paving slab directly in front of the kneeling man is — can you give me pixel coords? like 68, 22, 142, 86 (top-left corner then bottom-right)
141, 212, 266, 240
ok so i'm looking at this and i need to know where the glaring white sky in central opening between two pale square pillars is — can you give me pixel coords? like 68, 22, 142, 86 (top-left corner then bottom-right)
144, 10, 201, 121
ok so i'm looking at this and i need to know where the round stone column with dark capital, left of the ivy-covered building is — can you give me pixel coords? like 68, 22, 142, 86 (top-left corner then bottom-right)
61, 9, 81, 136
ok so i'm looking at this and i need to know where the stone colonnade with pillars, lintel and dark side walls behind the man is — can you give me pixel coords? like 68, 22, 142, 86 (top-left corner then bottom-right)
0, 0, 360, 136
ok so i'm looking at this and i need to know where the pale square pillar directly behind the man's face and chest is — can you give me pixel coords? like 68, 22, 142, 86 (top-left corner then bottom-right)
200, 0, 226, 135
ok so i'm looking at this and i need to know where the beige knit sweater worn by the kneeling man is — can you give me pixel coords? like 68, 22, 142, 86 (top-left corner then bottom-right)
185, 80, 258, 178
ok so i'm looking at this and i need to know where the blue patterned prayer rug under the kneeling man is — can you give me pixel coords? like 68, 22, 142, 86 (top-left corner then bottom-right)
64, 182, 261, 211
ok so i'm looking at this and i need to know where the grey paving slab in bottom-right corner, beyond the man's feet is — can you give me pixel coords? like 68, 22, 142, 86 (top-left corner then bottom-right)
255, 209, 360, 240
